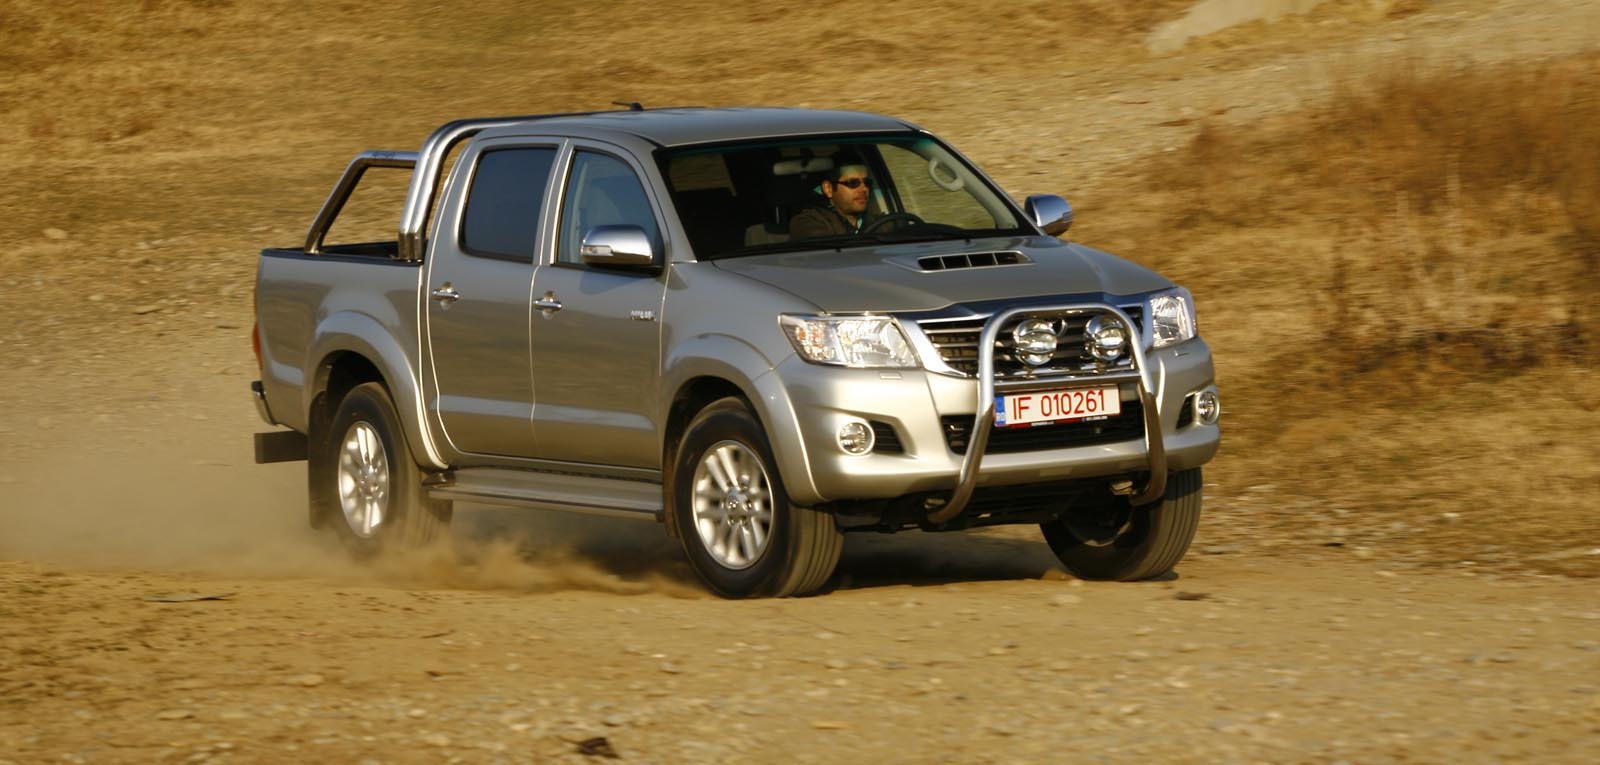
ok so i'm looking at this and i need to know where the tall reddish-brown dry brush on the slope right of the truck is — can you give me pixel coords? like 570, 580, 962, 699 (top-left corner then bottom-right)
1154, 54, 1600, 381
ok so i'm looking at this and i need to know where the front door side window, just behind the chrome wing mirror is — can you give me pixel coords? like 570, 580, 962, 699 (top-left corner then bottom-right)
555, 150, 661, 262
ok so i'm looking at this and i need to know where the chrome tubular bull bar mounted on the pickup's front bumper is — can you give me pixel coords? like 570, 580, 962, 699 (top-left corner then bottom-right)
928, 302, 1166, 525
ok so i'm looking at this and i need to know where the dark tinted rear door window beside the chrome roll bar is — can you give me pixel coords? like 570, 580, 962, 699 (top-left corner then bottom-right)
461, 149, 555, 261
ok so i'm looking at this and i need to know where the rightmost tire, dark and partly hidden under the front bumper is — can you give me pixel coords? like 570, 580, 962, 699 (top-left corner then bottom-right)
1040, 467, 1203, 581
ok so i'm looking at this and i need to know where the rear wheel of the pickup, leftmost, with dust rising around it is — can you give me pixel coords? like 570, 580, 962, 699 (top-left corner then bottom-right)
307, 383, 453, 560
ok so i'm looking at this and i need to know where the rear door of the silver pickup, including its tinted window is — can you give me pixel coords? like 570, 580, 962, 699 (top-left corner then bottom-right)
424, 139, 562, 456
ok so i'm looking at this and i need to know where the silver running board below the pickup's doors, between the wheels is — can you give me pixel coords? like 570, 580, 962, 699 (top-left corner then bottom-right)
427, 467, 664, 520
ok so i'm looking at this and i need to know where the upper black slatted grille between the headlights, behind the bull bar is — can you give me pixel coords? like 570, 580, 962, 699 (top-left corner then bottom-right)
917, 306, 1144, 379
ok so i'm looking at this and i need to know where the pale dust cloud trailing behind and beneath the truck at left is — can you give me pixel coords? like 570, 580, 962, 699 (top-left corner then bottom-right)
0, 416, 702, 597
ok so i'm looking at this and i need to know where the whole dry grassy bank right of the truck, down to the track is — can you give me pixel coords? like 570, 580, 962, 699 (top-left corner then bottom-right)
1131, 54, 1600, 575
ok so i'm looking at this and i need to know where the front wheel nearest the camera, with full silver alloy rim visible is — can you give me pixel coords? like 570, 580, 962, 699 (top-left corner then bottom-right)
669, 399, 845, 597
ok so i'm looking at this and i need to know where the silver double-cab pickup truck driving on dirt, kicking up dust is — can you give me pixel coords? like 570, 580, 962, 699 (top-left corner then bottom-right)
253, 104, 1221, 597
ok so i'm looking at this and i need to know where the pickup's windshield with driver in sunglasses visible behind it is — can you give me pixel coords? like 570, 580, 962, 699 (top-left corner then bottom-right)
661, 134, 1032, 259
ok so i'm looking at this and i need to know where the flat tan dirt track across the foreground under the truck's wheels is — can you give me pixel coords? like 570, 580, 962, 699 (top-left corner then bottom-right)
0, 550, 1600, 763
